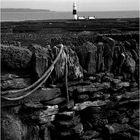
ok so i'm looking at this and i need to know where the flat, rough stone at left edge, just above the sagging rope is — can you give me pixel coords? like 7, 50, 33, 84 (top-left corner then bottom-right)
1, 78, 31, 90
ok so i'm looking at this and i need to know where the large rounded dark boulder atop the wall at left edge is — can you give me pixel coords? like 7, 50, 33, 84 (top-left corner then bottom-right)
1, 45, 32, 69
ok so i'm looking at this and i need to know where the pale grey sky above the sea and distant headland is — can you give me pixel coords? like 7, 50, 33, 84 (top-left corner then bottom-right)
1, 0, 139, 11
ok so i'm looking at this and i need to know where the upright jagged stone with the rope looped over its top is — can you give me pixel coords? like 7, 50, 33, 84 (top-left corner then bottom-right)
52, 45, 83, 82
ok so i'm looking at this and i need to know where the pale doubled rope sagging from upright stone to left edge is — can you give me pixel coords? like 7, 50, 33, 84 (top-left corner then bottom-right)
1, 44, 64, 101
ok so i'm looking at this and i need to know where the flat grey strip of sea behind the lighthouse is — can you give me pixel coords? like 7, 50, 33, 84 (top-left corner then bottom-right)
1, 11, 139, 21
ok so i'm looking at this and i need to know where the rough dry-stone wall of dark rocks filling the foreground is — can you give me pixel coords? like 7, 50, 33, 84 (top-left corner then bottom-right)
1, 34, 140, 140
